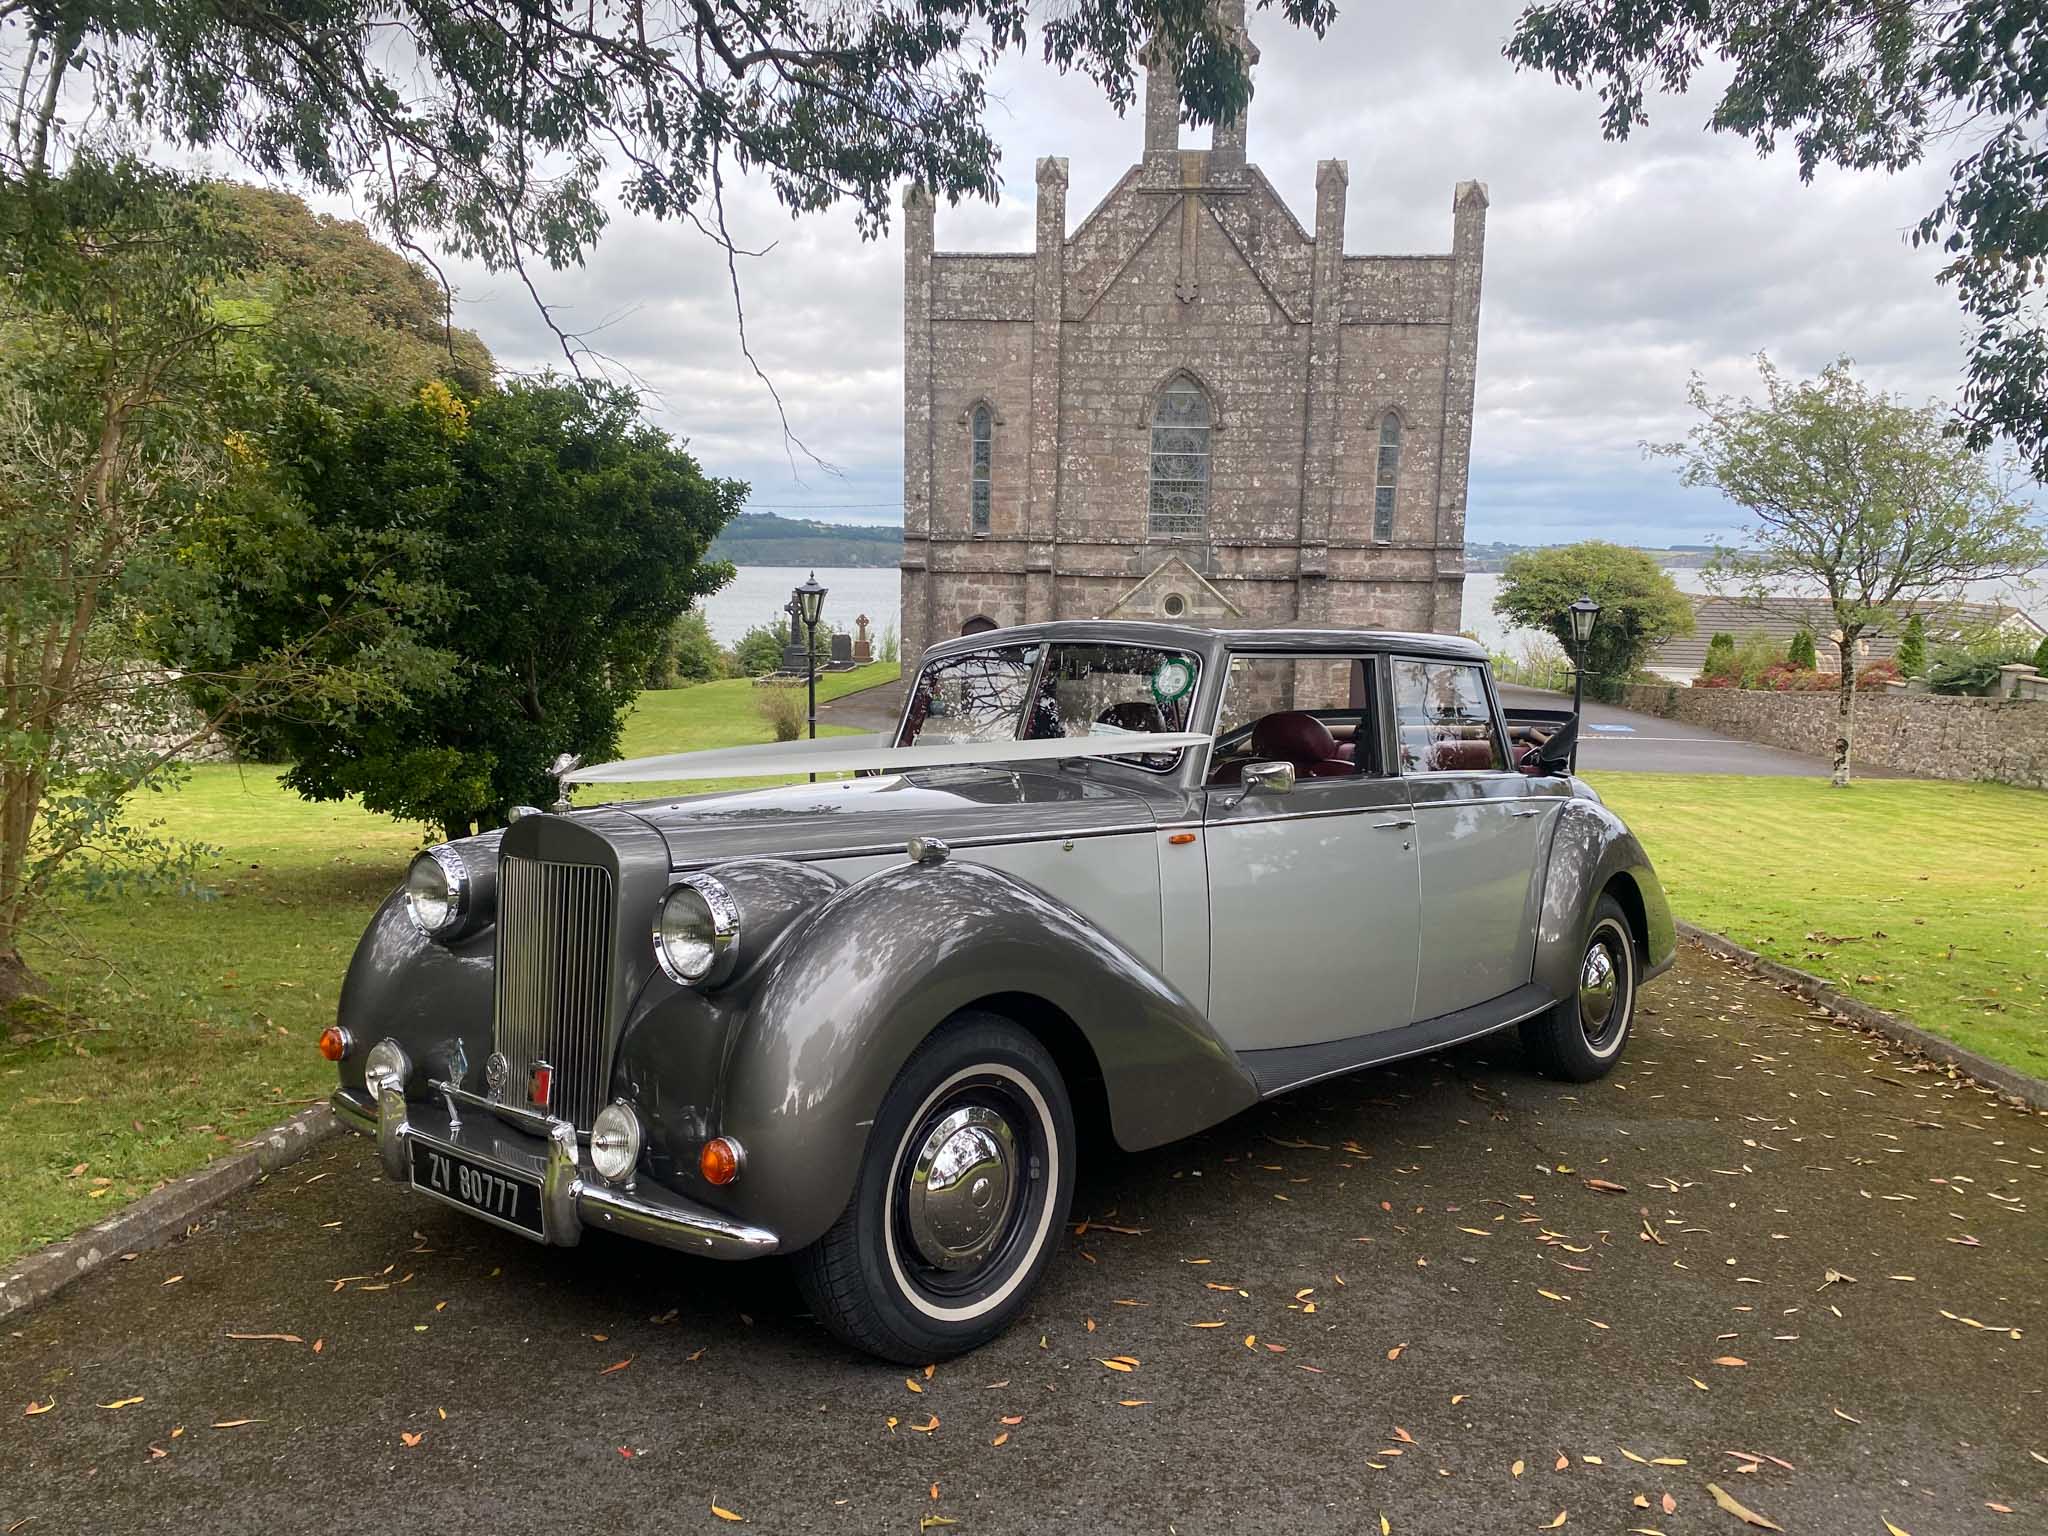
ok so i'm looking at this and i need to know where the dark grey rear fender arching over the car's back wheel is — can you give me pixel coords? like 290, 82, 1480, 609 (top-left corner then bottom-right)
1532, 797, 1677, 997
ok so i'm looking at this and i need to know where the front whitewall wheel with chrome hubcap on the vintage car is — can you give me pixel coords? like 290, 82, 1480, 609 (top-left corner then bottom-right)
795, 1012, 1075, 1364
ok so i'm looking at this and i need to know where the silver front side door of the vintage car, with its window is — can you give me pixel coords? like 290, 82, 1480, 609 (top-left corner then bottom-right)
1202, 655, 1419, 1051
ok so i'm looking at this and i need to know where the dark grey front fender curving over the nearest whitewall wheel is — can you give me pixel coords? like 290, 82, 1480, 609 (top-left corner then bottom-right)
719, 860, 1257, 1247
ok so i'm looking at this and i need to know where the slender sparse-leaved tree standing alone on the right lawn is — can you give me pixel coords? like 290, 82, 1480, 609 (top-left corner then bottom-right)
1659, 356, 2048, 786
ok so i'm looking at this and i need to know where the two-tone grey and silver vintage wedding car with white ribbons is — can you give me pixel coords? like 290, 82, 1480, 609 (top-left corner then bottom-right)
324, 621, 1673, 1362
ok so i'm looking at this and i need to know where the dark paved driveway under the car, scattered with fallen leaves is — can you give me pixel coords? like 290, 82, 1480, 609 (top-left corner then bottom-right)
0, 950, 2048, 1536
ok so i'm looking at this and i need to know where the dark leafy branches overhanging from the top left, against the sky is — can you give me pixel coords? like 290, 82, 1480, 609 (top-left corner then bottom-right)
0, 0, 1335, 364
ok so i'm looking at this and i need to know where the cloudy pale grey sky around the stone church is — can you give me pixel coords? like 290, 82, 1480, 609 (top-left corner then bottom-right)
391, 0, 1964, 545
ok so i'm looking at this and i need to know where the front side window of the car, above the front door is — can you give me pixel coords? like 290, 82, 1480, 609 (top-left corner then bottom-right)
1206, 655, 1380, 784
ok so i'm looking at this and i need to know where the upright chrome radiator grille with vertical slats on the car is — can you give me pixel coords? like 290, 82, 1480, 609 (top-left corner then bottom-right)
494, 854, 612, 1130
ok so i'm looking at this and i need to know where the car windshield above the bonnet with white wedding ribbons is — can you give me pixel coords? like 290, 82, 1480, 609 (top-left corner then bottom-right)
897, 645, 1200, 772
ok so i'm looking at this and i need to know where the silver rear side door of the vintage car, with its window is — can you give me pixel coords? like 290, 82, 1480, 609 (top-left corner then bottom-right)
1389, 657, 1559, 1020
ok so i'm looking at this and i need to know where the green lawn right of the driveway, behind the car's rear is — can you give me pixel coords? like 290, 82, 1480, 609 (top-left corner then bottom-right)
1589, 774, 2048, 1077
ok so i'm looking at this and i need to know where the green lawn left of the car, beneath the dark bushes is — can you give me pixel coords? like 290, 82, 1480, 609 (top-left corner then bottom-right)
0, 664, 897, 1262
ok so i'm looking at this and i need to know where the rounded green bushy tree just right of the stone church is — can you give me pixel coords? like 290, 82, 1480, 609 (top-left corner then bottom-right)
1493, 539, 1694, 698
